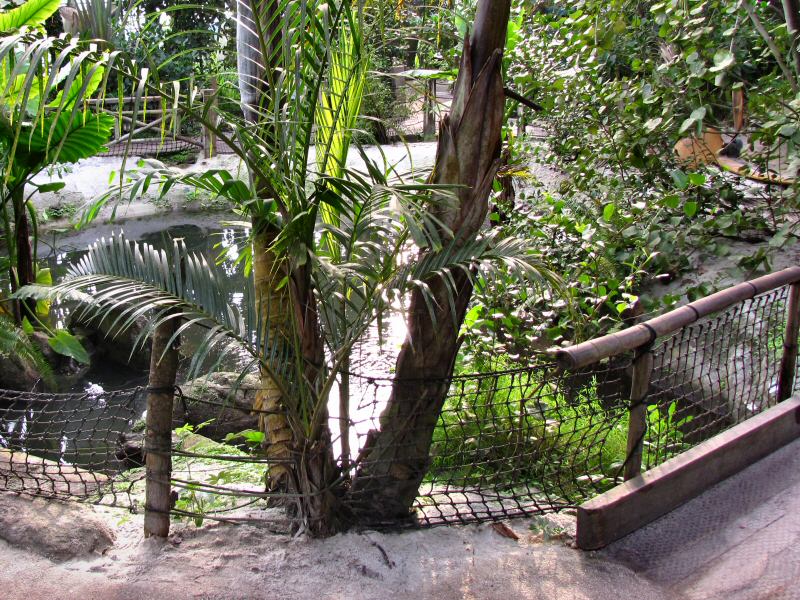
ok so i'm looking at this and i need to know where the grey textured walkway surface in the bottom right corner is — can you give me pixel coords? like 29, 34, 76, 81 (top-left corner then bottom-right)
601, 440, 800, 600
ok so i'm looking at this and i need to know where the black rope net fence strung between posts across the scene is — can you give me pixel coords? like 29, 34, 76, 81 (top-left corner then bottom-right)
0, 276, 797, 529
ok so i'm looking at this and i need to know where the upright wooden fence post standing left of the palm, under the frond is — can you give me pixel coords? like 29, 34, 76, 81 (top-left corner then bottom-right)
144, 317, 180, 537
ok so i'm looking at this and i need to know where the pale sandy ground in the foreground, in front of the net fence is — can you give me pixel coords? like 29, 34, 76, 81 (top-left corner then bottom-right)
0, 502, 673, 600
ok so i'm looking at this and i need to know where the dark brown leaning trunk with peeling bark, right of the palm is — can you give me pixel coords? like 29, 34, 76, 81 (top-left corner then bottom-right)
348, 0, 511, 521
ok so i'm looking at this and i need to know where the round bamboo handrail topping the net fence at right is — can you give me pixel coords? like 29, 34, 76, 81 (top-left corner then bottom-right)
555, 267, 800, 370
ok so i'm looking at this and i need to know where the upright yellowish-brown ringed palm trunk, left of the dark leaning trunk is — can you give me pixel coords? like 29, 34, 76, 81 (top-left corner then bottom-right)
236, 0, 339, 535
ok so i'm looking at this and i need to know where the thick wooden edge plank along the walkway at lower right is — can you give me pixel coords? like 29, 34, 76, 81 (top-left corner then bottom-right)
577, 395, 800, 550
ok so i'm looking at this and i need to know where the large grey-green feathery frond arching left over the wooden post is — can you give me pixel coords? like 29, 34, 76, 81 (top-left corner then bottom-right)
10, 235, 306, 390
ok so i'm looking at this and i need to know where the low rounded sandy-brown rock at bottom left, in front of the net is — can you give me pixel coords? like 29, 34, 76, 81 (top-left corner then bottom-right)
0, 492, 114, 560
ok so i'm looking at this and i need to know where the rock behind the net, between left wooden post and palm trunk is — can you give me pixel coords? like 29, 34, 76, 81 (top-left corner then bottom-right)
173, 372, 260, 441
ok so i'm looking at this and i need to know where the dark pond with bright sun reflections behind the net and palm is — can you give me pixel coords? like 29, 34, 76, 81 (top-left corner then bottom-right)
0, 215, 406, 470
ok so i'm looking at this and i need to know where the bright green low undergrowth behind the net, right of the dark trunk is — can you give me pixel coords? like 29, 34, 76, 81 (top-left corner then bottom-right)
425, 356, 690, 502
